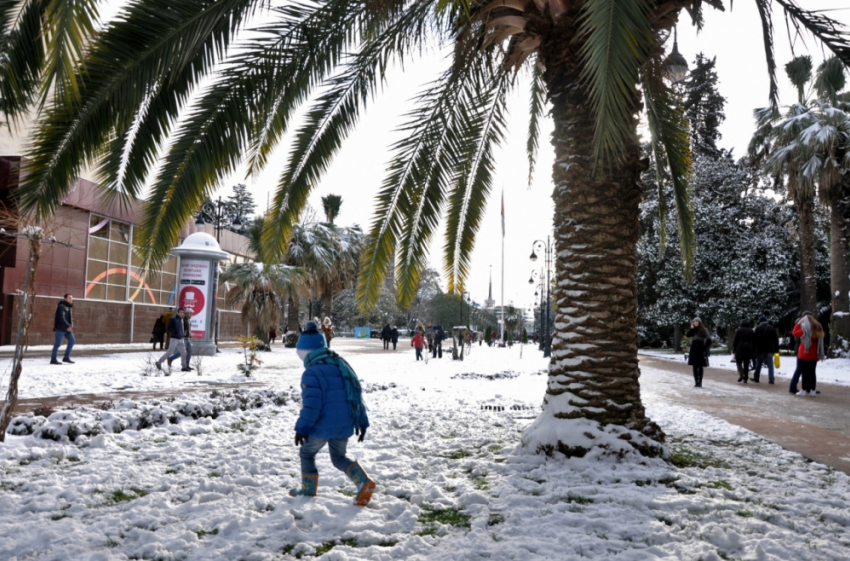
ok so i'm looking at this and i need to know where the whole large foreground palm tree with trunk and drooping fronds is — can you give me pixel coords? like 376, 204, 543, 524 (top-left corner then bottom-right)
11, 0, 850, 456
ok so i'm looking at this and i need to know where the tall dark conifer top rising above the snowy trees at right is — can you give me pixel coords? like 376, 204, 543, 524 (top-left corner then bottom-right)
682, 53, 726, 158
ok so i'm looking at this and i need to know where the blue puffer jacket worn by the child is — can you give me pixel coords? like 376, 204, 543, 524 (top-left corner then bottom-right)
295, 354, 369, 438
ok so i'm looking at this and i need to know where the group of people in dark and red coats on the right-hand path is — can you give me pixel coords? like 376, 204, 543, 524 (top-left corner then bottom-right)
685, 311, 826, 397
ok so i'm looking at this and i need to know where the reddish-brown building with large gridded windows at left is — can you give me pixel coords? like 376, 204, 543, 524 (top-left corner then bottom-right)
0, 156, 251, 345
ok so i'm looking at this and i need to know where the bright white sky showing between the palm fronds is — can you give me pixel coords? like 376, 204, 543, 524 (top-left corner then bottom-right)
219, 0, 850, 307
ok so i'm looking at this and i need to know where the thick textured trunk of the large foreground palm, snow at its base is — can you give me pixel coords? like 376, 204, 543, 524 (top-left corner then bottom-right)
523, 24, 664, 457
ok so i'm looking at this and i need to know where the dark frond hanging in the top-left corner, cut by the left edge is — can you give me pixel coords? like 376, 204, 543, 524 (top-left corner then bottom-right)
0, 0, 47, 125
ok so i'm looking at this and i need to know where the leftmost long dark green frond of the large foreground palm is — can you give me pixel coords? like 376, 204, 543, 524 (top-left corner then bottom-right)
18, 0, 266, 218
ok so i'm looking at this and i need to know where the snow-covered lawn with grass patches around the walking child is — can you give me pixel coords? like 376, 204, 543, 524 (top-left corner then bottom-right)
0, 342, 850, 561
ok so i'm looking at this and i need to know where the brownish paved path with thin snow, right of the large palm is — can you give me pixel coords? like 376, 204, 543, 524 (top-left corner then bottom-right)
640, 356, 850, 474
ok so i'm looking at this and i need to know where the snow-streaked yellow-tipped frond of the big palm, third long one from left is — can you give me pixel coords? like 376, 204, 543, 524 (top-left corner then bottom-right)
255, 2, 433, 260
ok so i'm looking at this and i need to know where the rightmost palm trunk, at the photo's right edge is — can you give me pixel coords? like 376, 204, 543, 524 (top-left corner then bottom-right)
829, 186, 850, 356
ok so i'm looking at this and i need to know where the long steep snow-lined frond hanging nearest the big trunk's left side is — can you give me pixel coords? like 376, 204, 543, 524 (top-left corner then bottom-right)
444, 65, 511, 292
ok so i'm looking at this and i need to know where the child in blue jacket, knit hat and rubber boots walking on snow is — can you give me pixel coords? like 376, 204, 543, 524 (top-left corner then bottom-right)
289, 321, 375, 506
